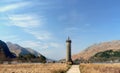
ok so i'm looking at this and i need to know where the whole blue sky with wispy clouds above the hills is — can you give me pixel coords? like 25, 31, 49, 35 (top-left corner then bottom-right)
0, 0, 120, 59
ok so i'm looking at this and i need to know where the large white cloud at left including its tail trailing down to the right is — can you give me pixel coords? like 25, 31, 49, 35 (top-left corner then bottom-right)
7, 14, 52, 41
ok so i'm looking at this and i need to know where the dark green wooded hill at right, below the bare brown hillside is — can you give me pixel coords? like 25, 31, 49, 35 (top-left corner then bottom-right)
89, 50, 120, 62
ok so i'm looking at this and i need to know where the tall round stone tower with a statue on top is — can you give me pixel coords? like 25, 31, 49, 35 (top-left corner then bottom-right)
66, 37, 73, 64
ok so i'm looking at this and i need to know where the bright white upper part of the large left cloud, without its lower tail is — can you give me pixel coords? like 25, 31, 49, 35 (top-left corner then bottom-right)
9, 14, 43, 28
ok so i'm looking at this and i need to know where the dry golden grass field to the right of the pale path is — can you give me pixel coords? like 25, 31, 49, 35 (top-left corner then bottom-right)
80, 63, 120, 73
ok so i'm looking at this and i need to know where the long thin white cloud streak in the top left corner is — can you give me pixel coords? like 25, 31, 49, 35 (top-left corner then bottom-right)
0, 2, 31, 12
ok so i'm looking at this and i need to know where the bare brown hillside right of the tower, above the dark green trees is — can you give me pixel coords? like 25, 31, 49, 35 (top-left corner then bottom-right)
72, 40, 120, 60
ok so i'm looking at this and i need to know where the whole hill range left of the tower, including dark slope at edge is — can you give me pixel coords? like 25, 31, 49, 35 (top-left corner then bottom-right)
0, 40, 46, 63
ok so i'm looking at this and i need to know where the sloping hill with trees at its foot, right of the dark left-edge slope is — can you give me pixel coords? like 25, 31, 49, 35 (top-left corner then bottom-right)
7, 42, 47, 62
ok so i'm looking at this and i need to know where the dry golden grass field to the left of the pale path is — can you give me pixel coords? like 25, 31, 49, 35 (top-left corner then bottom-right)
0, 64, 69, 73
